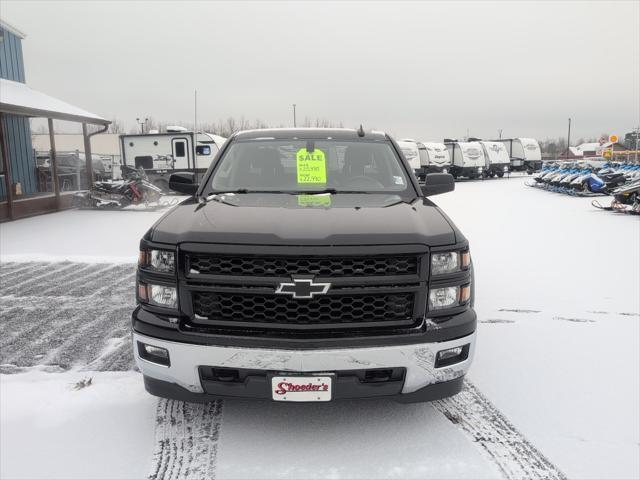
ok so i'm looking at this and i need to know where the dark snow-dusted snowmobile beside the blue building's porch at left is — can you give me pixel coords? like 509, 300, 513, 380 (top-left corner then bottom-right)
74, 169, 162, 208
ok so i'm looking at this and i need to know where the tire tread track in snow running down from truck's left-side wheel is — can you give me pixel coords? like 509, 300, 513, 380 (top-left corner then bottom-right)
149, 399, 223, 480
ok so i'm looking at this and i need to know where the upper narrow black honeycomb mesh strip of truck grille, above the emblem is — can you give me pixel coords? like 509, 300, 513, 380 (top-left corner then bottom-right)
189, 255, 418, 277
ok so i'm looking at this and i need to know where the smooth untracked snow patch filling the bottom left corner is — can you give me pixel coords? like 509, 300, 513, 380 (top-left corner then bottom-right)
0, 370, 157, 480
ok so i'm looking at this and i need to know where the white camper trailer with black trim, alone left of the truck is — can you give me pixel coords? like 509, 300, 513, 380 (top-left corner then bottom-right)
120, 127, 226, 191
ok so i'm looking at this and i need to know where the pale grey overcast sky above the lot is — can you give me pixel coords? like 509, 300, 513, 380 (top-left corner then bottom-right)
0, 0, 640, 140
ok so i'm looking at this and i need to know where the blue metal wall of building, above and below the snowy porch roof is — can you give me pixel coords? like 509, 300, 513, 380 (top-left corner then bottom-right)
0, 25, 38, 200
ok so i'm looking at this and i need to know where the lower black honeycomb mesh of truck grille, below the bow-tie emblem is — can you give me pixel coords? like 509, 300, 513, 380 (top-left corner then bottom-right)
193, 292, 414, 328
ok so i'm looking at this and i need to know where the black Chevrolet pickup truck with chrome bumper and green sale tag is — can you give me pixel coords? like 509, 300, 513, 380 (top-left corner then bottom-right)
132, 129, 476, 402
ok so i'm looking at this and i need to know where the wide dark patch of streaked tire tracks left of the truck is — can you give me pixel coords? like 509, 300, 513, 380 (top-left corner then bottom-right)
0, 262, 135, 373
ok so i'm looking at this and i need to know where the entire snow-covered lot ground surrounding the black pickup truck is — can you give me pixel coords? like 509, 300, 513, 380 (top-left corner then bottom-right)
0, 178, 640, 478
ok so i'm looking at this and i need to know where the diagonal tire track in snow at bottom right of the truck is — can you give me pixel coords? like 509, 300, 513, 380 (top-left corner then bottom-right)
433, 381, 567, 480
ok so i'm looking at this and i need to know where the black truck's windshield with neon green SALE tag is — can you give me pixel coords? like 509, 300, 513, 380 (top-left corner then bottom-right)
211, 139, 411, 193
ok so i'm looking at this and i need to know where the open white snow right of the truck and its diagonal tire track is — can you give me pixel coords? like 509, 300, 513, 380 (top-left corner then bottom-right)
436, 178, 640, 478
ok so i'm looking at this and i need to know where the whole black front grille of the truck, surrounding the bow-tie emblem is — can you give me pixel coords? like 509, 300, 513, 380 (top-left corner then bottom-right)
178, 249, 428, 338
